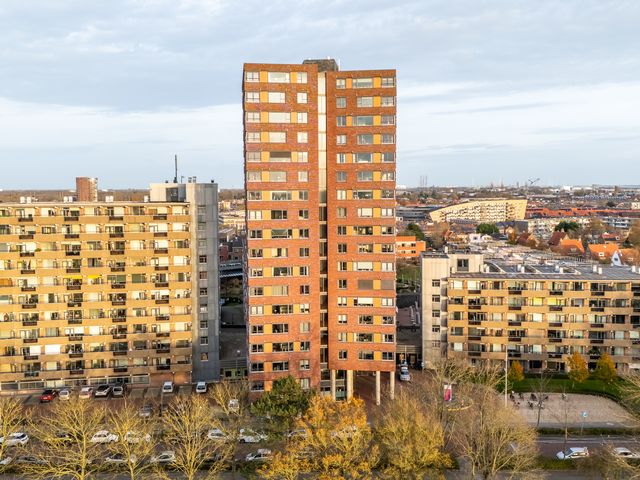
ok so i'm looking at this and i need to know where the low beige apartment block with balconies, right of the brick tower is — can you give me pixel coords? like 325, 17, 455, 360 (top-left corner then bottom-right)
422, 253, 640, 372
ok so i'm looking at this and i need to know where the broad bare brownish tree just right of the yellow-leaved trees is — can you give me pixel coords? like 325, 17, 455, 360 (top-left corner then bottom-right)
451, 386, 537, 479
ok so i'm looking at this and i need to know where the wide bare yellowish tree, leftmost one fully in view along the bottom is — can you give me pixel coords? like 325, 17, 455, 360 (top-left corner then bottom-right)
24, 397, 105, 480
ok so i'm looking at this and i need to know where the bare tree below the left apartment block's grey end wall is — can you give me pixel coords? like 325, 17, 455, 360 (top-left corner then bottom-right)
158, 395, 228, 480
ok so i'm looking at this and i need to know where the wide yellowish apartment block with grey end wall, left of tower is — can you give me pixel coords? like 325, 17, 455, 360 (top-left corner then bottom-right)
0, 178, 219, 392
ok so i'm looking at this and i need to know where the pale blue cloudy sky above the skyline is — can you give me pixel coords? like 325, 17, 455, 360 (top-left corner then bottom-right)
0, 0, 640, 189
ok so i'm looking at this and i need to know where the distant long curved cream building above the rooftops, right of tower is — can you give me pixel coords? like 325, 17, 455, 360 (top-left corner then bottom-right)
431, 198, 527, 223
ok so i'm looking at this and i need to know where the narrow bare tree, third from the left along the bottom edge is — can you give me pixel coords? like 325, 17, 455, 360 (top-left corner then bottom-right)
107, 401, 156, 480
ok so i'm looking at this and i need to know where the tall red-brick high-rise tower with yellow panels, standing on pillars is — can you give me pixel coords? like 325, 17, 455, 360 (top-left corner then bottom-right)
243, 59, 396, 401
